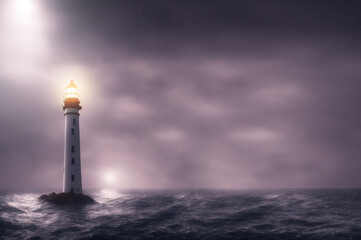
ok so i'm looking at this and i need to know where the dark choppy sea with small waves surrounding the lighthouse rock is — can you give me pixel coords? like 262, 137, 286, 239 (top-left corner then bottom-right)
0, 189, 361, 240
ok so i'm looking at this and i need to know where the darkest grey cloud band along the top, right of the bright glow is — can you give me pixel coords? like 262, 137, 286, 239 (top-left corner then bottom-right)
47, 1, 360, 58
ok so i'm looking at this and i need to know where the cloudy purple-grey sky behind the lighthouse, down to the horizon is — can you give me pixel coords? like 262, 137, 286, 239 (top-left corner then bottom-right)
0, 0, 361, 190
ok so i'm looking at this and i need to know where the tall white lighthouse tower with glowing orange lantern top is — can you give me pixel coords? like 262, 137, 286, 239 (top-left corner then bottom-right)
63, 80, 83, 194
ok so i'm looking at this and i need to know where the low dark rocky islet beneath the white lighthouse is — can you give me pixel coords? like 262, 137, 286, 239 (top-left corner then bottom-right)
39, 192, 96, 205
